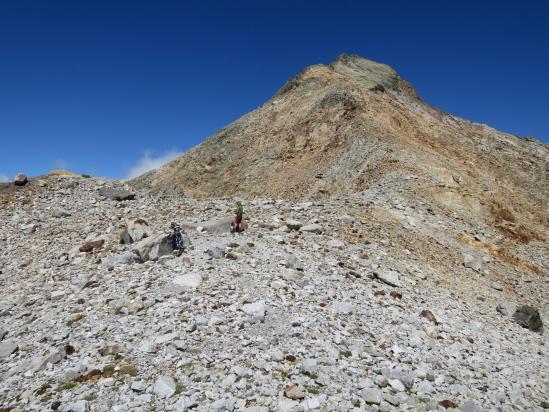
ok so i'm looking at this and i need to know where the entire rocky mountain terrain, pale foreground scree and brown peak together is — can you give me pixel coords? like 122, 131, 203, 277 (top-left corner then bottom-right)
0, 56, 549, 412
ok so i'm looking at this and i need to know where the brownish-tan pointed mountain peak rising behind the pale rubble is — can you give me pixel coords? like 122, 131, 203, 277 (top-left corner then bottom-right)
131, 55, 549, 242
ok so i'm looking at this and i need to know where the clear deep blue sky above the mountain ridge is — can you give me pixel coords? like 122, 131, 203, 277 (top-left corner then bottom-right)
0, 0, 549, 178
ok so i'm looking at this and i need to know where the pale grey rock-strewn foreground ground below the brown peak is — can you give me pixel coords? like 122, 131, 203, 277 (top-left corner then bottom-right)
0, 176, 549, 412
